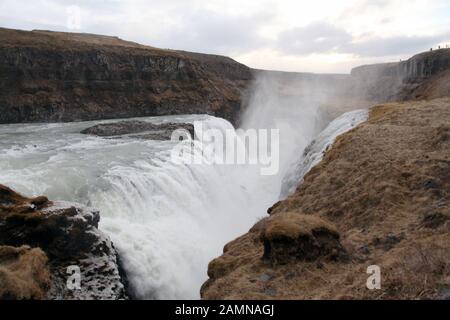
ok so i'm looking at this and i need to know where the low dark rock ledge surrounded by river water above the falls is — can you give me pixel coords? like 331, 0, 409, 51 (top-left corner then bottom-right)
81, 120, 194, 140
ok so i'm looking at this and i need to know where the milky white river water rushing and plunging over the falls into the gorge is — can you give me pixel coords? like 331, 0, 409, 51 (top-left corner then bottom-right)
0, 99, 366, 299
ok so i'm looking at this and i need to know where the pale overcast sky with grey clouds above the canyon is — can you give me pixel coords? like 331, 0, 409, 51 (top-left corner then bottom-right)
0, 0, 450, 73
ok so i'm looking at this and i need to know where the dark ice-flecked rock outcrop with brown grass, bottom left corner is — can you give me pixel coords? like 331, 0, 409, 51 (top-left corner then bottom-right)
0, 185, 127, 299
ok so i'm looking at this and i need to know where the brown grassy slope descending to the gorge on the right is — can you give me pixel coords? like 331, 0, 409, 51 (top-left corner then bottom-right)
201, 98, 450, 299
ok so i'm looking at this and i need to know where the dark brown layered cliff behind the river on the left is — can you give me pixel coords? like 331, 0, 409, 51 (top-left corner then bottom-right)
0, 28, 252, 123
